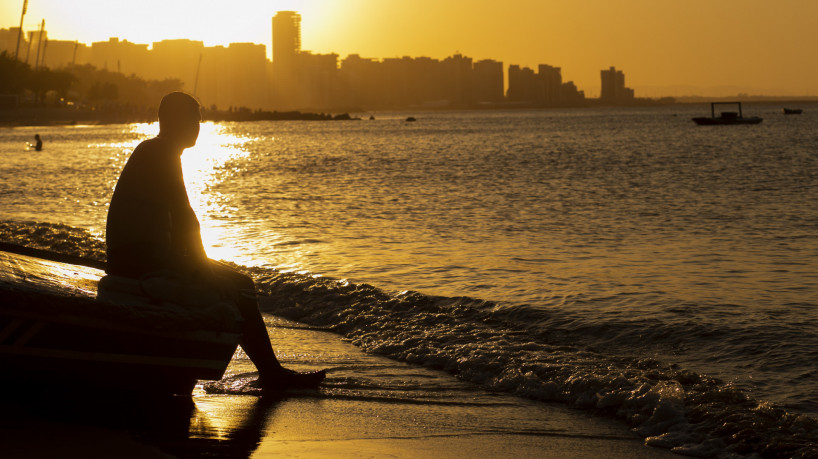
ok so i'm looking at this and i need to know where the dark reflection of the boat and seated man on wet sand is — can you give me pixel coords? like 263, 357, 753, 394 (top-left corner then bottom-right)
0, 393, 277, 457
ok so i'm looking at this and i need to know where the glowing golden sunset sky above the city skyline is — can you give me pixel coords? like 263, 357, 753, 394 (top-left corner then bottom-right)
0, 0, 818, 96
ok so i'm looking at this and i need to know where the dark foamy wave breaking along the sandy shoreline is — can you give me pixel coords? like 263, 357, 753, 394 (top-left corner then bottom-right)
0, 222, 818, 458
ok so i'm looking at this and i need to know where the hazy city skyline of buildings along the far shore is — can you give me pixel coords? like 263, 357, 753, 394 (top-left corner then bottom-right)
0, 11, 634, 111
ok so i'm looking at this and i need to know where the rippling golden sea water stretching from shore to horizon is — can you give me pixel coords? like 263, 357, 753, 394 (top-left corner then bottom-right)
0, 104, 818, 457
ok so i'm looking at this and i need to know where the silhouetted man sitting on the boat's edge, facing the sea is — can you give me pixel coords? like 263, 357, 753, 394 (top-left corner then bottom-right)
106, 92, 325, 390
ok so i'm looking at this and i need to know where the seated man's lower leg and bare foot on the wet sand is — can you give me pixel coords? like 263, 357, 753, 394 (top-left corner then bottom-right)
211, 262, 325, 388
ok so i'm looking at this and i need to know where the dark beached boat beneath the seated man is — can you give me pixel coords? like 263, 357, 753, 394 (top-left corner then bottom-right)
0, 244, 241, 395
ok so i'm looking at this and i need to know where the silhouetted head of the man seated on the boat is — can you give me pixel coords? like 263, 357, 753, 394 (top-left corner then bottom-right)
159, 92, 202, 148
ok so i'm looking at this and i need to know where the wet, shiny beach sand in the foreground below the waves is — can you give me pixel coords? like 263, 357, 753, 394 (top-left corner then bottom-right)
0, 324, 675, 458
